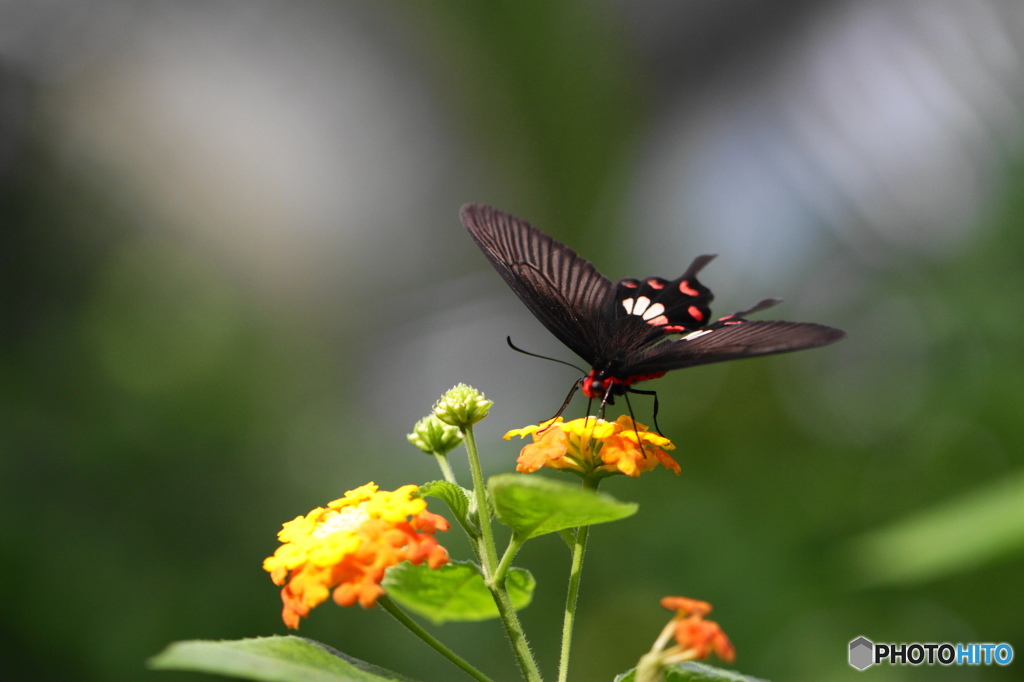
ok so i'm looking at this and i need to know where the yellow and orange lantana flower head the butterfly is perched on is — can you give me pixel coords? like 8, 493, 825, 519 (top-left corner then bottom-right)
505, 415, 679, 476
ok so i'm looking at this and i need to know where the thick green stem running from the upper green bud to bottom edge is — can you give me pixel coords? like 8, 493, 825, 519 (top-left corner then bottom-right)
462, 425, 541, 682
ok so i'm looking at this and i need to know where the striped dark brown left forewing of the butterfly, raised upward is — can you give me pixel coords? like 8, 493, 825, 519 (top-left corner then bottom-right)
460, 204, 612, 365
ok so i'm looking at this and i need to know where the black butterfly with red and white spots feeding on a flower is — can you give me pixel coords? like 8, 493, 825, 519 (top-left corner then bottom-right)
460, 199, 846, 417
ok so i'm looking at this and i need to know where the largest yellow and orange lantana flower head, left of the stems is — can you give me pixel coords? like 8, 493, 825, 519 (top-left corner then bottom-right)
263, 483, 449, 628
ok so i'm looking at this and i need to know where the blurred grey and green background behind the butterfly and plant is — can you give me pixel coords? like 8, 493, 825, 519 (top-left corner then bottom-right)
0, 0, 1024, 682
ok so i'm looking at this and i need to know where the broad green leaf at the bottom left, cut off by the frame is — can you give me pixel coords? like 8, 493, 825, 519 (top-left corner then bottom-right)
147, 635, 414, 682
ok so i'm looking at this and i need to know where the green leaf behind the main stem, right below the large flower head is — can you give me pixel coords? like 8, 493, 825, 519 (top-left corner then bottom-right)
383, 561, 537, 624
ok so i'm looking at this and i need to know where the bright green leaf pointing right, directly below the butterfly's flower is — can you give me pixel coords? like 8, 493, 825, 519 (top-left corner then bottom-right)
487, 474, 639, 541
